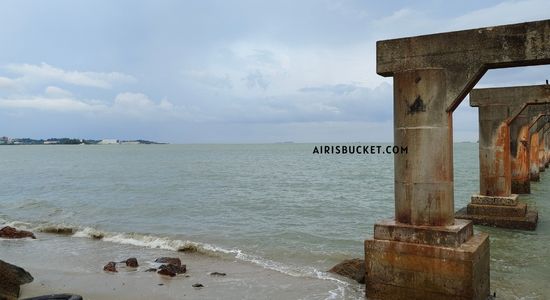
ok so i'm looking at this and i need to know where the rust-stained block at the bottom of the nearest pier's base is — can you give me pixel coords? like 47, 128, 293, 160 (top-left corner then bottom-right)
365, 234, 489, 300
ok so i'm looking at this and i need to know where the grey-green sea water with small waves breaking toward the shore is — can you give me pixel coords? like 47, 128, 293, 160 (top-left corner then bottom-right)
0, 143, 550, 299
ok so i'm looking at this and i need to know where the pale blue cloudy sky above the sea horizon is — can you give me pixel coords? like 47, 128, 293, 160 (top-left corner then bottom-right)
0, 0, 550, 143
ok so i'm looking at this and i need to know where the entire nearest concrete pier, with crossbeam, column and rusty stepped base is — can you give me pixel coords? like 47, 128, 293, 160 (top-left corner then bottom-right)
365, 20, 550, 300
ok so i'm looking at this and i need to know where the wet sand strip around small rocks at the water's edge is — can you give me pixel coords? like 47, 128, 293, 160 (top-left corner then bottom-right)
0, 233, 364, 300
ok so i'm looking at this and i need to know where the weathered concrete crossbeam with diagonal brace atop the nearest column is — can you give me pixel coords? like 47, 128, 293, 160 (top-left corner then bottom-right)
376, 20, 550, 111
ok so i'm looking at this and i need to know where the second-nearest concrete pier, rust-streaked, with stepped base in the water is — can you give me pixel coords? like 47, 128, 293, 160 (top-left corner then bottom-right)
455, 85, 550, 230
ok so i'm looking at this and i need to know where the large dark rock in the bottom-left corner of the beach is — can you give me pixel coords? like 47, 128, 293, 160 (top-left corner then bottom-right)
0, 260, 34, 300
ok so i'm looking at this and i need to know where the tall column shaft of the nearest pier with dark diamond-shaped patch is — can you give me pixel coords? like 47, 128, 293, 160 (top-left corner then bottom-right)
394, 69, 454, 226
